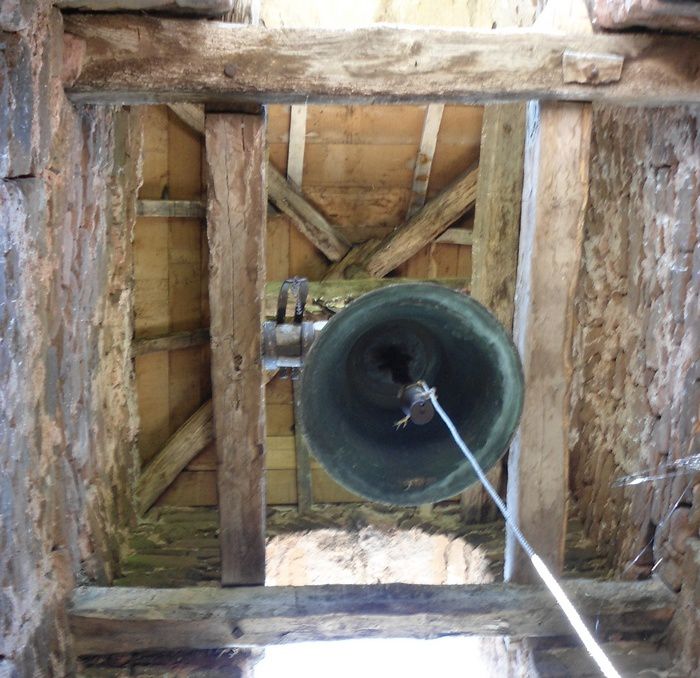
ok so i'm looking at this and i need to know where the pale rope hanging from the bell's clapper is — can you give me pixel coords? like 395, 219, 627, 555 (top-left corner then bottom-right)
421, 383, 621, 678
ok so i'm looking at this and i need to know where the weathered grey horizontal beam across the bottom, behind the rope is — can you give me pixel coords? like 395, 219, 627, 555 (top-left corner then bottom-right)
69, 580, 675, 655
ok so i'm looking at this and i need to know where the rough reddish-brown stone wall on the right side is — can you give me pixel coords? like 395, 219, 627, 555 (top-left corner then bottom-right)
571, 107, 700, 588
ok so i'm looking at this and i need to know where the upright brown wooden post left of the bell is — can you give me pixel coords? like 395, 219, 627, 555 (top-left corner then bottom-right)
205, 114, 267, 585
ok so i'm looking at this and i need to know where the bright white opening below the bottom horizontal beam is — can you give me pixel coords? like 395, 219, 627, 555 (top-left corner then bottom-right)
255, 638, 493, 678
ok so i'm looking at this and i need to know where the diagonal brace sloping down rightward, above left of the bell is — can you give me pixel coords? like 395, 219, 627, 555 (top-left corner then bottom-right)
267, 165, 350, 261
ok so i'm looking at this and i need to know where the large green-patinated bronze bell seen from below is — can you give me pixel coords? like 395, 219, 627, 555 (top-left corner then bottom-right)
300, 283, 523, 506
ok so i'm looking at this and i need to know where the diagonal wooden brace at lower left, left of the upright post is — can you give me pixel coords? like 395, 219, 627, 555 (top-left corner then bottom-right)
136, 400, 214, 514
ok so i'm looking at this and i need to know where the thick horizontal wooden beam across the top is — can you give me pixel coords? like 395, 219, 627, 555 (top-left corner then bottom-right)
65, 14, 700, 106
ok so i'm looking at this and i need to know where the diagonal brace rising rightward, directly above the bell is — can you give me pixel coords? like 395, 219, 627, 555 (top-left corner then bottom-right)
354, 167, 479, 278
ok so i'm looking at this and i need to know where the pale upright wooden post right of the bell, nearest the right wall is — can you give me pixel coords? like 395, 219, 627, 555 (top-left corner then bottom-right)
505, 101, 591, 583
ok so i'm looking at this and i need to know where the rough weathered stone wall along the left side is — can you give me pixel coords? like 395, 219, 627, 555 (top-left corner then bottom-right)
0, 0, 141, 678
